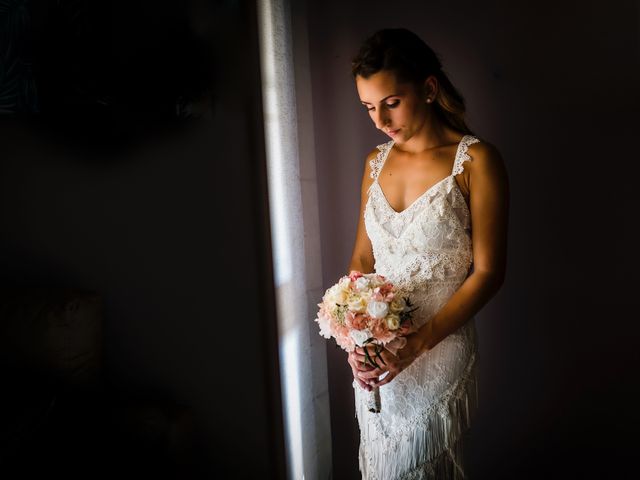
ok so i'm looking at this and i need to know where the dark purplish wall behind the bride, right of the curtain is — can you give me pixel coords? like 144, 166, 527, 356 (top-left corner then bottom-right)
308, 0, 640, 480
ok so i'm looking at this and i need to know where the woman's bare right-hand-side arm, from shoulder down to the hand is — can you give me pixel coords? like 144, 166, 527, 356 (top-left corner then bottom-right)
355, 143, 509, 387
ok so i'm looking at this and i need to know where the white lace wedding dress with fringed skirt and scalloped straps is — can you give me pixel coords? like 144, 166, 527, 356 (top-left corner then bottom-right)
353, 135, 479, 480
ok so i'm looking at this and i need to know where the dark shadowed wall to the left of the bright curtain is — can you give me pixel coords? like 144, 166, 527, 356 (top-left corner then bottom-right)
0, 0, 284, 478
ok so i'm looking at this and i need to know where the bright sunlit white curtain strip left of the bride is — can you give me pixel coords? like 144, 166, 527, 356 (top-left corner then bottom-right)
257, 0, 331, 480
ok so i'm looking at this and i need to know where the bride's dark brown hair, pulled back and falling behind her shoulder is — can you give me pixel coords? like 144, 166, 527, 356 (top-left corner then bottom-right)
351, 28, 473, 134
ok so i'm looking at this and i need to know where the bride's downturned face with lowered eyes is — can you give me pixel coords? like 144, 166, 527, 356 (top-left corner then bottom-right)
356, 70, 427, 143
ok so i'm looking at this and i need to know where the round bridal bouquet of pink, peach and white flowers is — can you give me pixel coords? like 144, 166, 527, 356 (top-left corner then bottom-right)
315, 270, 416, 413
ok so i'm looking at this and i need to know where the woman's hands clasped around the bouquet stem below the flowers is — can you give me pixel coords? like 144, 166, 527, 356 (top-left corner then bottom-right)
354, 332, 427, 387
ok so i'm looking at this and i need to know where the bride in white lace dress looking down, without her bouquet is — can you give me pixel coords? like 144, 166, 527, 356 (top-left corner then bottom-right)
348, 28, 509, 480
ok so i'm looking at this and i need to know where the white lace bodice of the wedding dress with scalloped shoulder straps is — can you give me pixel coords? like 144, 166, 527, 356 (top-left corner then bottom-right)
364, 135, 479, 302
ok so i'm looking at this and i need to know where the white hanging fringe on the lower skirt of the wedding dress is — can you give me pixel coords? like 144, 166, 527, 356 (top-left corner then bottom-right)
354, 353, 478, 480
